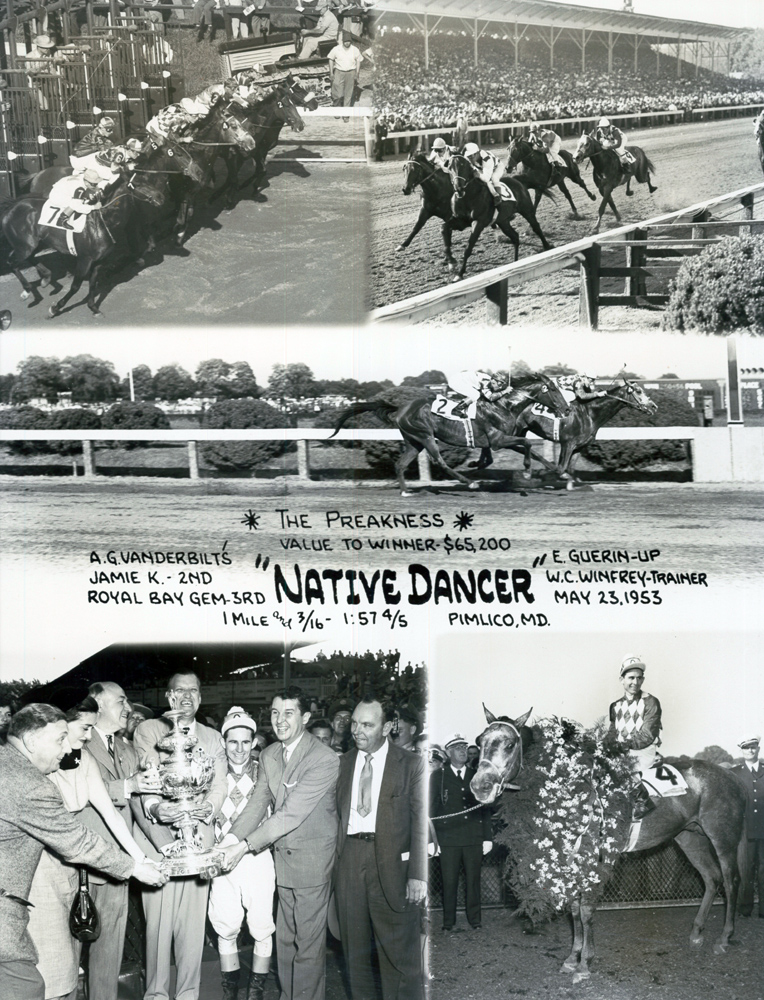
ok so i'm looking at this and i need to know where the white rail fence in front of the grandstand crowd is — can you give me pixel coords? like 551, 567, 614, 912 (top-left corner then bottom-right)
385, 104, 764, 154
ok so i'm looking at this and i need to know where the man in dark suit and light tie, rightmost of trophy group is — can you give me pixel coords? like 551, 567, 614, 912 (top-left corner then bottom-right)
335, 697, 427, 1000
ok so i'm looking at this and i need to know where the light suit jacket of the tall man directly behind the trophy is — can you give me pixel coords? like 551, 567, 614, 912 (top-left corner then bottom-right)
130, 716, 228, 860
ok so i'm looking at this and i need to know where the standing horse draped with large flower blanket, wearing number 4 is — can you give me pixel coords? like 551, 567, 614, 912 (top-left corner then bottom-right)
471, 714, 746, 982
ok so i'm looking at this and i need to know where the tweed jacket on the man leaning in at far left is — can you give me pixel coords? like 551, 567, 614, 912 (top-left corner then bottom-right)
0, 745, 135, 962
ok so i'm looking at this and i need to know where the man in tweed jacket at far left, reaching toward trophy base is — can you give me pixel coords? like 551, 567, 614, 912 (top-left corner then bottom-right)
0, 704, 164, 1000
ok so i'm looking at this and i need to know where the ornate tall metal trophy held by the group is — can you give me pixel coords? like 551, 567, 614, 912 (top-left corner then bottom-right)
157, 709, 223, 879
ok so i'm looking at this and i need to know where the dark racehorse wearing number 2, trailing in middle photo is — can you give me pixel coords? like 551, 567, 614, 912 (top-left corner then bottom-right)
331, 374, 568, 496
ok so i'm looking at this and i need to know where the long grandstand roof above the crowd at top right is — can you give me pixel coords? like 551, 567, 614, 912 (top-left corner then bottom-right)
374, 0, 746, 42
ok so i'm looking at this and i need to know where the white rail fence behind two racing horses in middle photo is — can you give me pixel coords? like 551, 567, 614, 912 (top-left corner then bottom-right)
0, 424, 764, 484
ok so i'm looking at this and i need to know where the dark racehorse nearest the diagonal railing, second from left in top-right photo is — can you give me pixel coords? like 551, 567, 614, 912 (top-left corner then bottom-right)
443, 154, 551, 280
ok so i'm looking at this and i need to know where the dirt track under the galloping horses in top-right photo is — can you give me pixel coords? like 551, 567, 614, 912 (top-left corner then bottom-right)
369, 118, 762, 308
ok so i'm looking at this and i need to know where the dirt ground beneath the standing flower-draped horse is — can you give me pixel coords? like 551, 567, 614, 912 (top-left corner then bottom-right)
430, 906, 764, 1000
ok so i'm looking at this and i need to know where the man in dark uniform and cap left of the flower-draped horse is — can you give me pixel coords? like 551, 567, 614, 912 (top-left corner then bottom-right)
430, 733, 493, 931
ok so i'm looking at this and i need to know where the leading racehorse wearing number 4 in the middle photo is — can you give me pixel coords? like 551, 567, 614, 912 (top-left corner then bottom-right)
508, 379, 658, 479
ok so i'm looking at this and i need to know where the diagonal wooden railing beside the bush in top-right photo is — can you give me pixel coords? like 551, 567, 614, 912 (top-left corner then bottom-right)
370, 183, 764, 329
